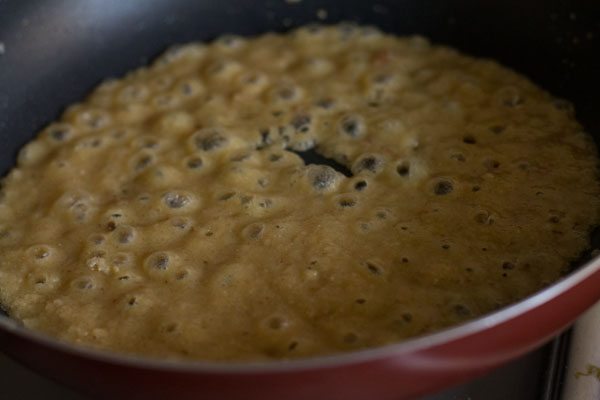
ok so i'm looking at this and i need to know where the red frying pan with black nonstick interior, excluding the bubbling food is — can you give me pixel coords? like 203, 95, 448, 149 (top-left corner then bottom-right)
0, 0, 600, 400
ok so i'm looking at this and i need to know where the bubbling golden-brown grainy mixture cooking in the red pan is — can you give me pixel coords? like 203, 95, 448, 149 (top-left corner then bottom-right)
0, 25, 600, 361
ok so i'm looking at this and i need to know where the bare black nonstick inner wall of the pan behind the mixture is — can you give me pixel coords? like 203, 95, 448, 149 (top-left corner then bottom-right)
0, 0, 600, 318
